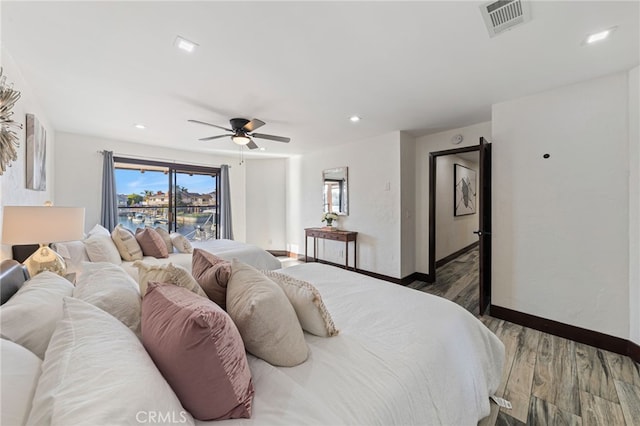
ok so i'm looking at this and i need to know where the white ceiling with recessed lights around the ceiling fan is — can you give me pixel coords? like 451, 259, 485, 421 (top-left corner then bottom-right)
1, 1, 640, 156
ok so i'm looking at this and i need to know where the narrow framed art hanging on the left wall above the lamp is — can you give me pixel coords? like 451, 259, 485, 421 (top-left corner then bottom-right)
26, 114, 47, 191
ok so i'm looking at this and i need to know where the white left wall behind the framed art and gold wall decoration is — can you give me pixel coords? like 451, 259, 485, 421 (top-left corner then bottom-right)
0, 48, 55, 259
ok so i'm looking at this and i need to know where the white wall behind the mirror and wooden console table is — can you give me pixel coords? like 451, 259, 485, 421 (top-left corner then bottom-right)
287, 132, 401, 278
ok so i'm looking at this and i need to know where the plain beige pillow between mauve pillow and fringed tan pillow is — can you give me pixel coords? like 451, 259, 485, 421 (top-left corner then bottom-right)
227, 259, 309, 367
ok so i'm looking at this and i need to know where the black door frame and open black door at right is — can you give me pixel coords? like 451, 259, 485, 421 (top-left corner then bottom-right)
429, 138, 491, 315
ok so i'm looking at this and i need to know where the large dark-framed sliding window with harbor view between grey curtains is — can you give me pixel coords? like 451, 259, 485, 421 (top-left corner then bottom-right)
114, 157, 220, 240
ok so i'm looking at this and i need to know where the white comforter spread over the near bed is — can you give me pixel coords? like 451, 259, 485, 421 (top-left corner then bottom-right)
198, 263, 504, 425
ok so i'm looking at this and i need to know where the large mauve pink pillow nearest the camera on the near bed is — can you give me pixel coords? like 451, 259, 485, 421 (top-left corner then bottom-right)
142, 283, 254, 420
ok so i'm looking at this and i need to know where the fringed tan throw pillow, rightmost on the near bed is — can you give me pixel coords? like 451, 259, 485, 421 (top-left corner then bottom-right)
262, 271, 339, 337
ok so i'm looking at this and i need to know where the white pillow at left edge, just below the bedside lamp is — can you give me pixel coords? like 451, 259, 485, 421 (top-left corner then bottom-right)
0, 271, 73, 358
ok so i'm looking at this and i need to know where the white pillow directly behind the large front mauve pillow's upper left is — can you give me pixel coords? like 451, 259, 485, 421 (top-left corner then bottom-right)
73, 262, 142, 336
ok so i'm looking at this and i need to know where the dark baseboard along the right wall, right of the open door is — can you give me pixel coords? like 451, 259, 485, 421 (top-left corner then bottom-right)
489, 305, 640, 362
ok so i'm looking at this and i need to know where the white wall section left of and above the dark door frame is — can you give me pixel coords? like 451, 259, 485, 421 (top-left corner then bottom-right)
415, 121, 491, 273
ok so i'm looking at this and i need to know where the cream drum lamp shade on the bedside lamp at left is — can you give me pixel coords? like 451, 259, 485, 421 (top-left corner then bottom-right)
2, 206, 84, 245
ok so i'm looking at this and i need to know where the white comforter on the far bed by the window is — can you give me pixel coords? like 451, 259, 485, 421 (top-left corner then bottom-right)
120, 240, 282, 282
